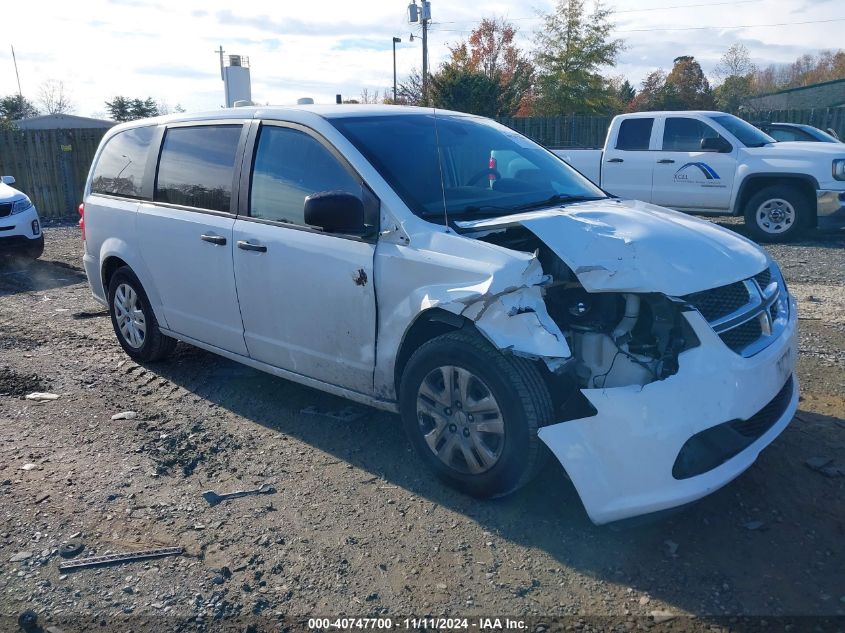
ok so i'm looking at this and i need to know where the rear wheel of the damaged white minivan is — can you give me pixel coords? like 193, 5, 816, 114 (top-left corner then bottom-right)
108, 266, 176, 362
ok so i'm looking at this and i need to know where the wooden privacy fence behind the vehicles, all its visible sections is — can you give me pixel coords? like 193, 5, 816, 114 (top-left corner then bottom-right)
0, 108, 845, 218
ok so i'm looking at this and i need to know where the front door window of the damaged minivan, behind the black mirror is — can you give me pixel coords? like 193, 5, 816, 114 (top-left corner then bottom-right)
249, 125, 362, 226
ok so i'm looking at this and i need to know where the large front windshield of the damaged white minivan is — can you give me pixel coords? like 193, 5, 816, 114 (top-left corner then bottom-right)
330, 112, 606, 223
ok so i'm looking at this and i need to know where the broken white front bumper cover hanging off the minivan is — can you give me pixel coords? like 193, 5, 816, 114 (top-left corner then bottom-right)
539, 298, 798, 524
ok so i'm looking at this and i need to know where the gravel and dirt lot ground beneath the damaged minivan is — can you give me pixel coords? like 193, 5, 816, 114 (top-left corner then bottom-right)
0, 220, 845, 630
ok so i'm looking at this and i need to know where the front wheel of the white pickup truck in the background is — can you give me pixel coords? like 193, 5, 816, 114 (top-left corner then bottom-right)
745, 185, 810, 242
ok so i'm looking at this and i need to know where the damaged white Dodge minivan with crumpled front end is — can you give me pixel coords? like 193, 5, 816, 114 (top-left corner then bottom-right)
80, 105, 798, 523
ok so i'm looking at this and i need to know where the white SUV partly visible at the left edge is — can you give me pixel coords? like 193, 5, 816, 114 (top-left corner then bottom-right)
0, 176, 44, 259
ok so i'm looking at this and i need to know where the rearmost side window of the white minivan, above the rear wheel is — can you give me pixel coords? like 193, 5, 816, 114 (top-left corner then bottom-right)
91, 126, 155, 198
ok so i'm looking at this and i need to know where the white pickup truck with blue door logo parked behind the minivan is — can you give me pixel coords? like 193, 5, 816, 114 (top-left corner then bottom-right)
555, 112, 845, 242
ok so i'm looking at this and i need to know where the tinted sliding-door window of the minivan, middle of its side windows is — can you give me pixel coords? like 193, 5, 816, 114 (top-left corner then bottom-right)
153, 125, 241, 212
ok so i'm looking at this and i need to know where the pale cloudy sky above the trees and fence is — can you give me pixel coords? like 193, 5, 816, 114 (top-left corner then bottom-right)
0, 0, 845, 116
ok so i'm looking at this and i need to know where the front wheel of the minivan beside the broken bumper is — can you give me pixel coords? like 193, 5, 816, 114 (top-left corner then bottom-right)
399, 331, 552, 498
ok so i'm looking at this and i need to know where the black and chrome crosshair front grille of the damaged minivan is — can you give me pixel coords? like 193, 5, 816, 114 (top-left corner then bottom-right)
683, 268, 789, 357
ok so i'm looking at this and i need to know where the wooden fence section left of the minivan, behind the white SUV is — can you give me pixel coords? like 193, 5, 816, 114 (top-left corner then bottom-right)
0, 129, 106, 218
